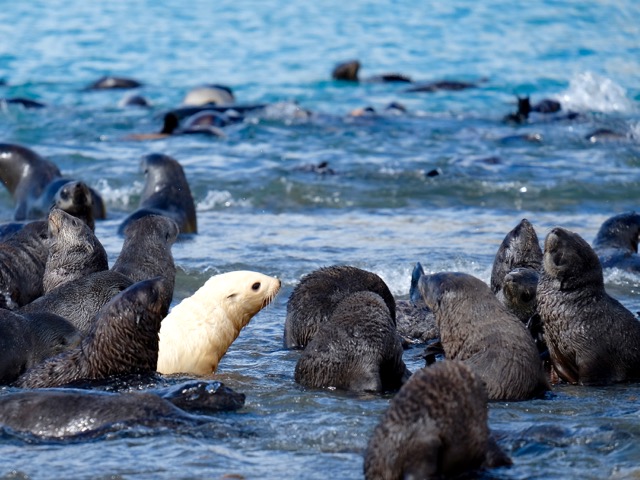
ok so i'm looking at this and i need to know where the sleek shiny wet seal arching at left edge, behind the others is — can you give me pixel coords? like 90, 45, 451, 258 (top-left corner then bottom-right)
0, 143, 106, 220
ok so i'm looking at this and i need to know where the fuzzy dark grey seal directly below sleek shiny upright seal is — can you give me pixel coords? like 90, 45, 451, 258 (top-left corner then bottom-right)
111, 215, 180, 288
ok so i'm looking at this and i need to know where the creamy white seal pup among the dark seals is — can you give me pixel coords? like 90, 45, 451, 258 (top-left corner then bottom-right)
158, 270, 281, 375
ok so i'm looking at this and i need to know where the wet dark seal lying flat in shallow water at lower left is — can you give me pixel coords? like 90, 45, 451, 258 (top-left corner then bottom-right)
0, 381, 245, 439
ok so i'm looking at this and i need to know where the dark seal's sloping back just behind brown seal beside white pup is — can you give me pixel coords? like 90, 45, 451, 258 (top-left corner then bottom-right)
19, 270, 133, 335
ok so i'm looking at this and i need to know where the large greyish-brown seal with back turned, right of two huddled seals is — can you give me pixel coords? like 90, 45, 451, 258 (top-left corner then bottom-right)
419, 272, 549, 400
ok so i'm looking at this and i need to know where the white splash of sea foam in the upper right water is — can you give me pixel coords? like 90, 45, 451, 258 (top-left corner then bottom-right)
559, 72, 637, 113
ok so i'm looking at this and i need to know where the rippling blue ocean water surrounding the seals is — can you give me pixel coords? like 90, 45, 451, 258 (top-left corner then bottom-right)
0, 0, 640, 479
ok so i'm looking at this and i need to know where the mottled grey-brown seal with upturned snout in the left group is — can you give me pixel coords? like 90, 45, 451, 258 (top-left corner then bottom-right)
42, 208, 109, 294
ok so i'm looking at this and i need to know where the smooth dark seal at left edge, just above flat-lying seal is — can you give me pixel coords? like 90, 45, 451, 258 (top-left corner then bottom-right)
0, 308, 80, 385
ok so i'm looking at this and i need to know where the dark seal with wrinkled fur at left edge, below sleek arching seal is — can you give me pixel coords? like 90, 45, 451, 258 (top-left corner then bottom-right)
0, 220, 49, 310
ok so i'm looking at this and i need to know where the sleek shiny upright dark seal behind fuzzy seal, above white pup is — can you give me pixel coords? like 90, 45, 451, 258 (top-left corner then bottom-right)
118, 153, 198, 233
